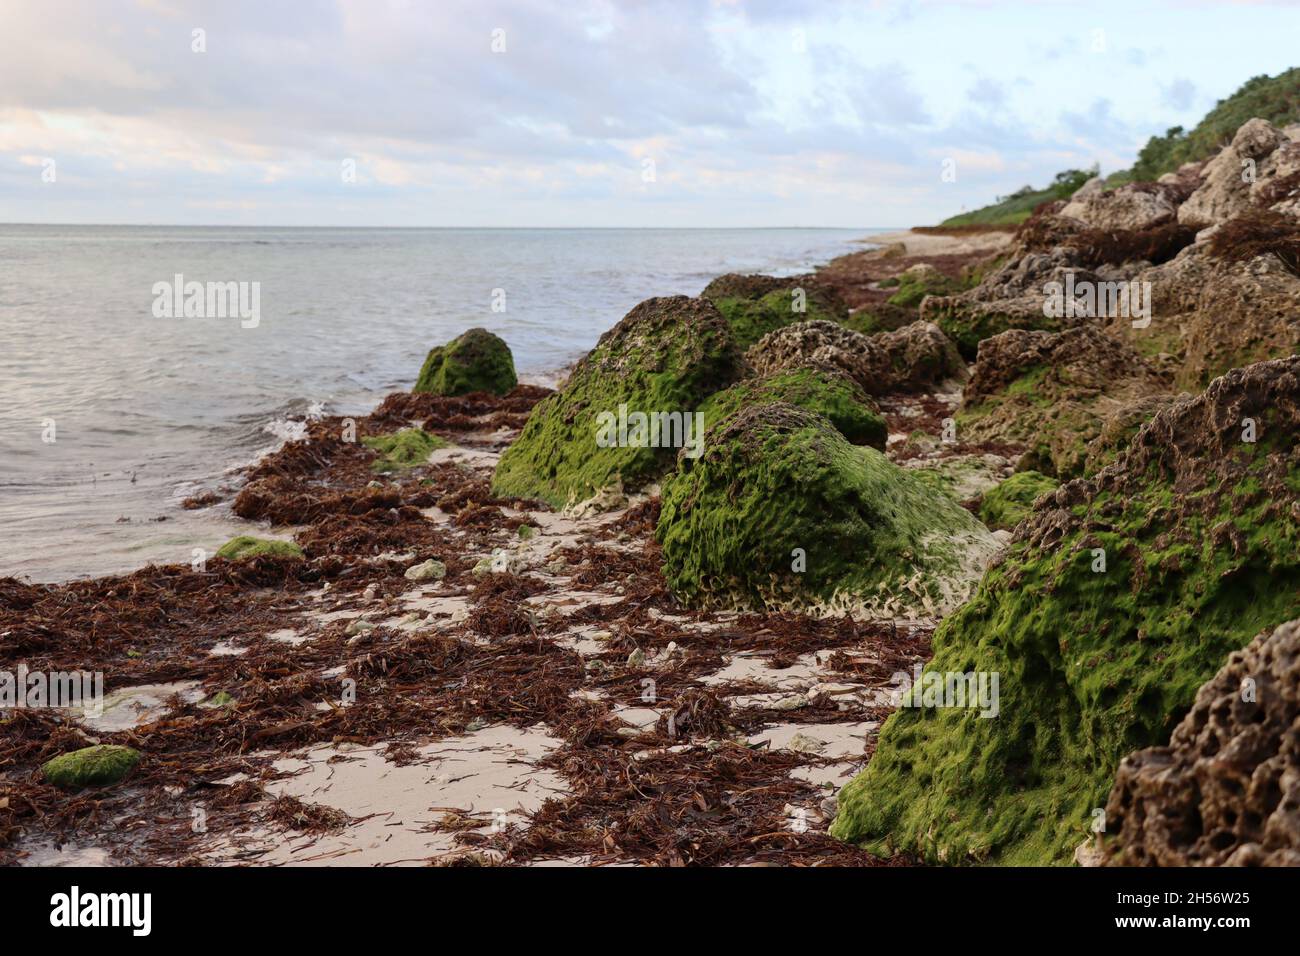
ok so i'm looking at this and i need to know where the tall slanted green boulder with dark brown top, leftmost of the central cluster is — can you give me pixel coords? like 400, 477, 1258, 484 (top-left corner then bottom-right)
493, 295, 742, 507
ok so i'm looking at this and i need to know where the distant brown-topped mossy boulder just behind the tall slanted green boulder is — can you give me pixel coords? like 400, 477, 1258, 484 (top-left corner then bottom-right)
701, 273, 849, 349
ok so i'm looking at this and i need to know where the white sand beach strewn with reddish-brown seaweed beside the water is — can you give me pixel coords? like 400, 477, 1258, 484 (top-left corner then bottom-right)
0, 233, 1006, 865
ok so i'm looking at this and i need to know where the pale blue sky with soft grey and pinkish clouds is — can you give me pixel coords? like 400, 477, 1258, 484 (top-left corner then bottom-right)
0, 0, 1300, 228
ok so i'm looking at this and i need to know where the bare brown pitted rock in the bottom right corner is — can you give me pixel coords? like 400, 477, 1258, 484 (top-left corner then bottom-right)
1099, 620, 1300, 866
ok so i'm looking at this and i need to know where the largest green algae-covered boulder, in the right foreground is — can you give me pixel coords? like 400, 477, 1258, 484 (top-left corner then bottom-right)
831, 358, 1300, 865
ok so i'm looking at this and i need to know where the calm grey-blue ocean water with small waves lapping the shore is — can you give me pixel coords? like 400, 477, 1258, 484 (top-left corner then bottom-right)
0, 225, 876, 581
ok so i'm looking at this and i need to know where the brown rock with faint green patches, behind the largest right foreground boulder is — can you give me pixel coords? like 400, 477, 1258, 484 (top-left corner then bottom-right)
957, 328, 1167, 479
